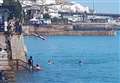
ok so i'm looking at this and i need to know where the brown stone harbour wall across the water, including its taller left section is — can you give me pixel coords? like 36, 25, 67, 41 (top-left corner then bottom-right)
23, 25, 117, 36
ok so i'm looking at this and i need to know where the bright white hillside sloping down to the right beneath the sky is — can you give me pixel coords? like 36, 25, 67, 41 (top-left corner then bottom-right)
20, 0, 90, 13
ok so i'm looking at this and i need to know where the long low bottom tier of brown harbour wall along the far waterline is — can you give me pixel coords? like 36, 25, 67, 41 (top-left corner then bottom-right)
24, 31, 116, 36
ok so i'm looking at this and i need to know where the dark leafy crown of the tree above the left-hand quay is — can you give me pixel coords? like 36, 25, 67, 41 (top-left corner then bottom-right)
3, 0, 22, 19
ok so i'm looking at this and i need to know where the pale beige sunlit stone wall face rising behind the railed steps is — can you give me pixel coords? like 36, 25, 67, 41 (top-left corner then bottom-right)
11, 35, 26, 61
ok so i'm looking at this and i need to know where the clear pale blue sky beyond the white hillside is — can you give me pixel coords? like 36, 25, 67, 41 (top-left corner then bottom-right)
68, 0, 120, 14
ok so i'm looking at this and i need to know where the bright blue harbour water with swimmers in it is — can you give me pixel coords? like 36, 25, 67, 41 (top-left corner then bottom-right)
17, 33, 120, 83
